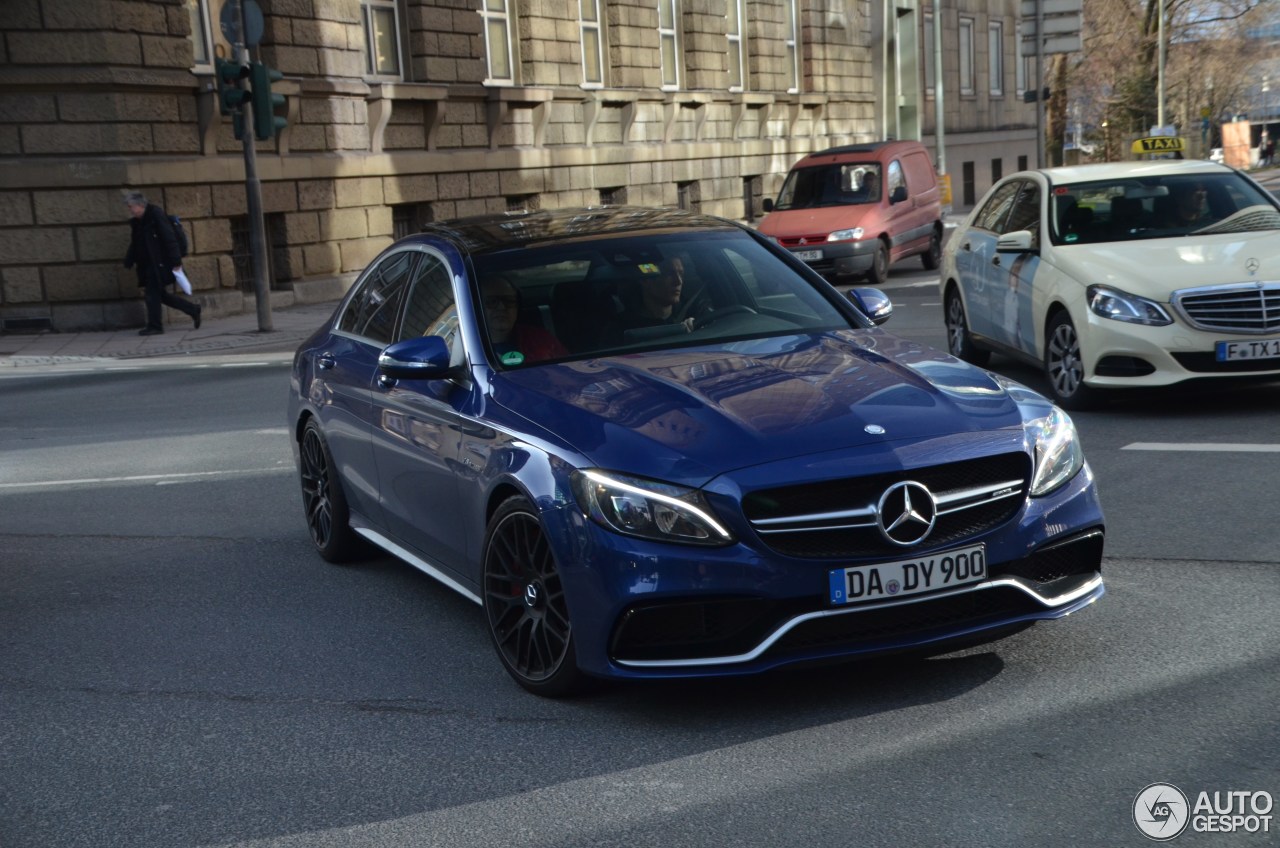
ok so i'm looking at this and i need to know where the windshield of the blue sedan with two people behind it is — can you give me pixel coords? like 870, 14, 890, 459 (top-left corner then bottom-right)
472, 231, 869, 366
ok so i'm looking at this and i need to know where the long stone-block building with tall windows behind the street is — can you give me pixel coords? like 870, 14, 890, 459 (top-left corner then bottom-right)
0, 0, 1034, 332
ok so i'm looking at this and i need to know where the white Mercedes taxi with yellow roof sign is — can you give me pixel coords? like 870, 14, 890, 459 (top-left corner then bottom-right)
941, 160, 1280, 410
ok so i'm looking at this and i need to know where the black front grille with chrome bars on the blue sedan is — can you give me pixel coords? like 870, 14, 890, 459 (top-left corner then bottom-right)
742, 452, 1030, 559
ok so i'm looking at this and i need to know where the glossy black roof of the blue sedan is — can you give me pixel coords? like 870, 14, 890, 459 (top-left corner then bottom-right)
404, 206, 739, 254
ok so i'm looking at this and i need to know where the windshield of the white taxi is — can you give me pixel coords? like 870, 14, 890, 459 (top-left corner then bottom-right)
1051, 173, 1280, 245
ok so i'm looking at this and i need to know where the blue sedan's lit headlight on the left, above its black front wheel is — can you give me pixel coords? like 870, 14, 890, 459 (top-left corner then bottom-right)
572, 470, 733, 544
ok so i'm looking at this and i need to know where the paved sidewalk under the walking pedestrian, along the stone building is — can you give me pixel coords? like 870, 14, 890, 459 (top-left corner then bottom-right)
0, 301, 338, 370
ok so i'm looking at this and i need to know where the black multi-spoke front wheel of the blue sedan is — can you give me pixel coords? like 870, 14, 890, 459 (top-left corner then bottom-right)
484, 496, 586, 698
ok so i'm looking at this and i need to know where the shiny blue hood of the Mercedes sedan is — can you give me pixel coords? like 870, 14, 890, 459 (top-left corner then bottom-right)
492, 329, 1021, 485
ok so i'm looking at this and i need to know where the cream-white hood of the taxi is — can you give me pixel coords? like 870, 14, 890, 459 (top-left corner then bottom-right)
1055, 231, 1280, 304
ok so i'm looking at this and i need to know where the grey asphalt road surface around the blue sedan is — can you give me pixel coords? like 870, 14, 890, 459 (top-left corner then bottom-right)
0, 297, 1280, 848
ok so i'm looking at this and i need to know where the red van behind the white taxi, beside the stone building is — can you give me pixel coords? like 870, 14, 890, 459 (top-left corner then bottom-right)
759, 141, 942, 286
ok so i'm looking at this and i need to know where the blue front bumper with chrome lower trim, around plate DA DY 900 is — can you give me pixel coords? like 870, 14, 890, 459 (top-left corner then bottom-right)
558, 456, 1105, 678
